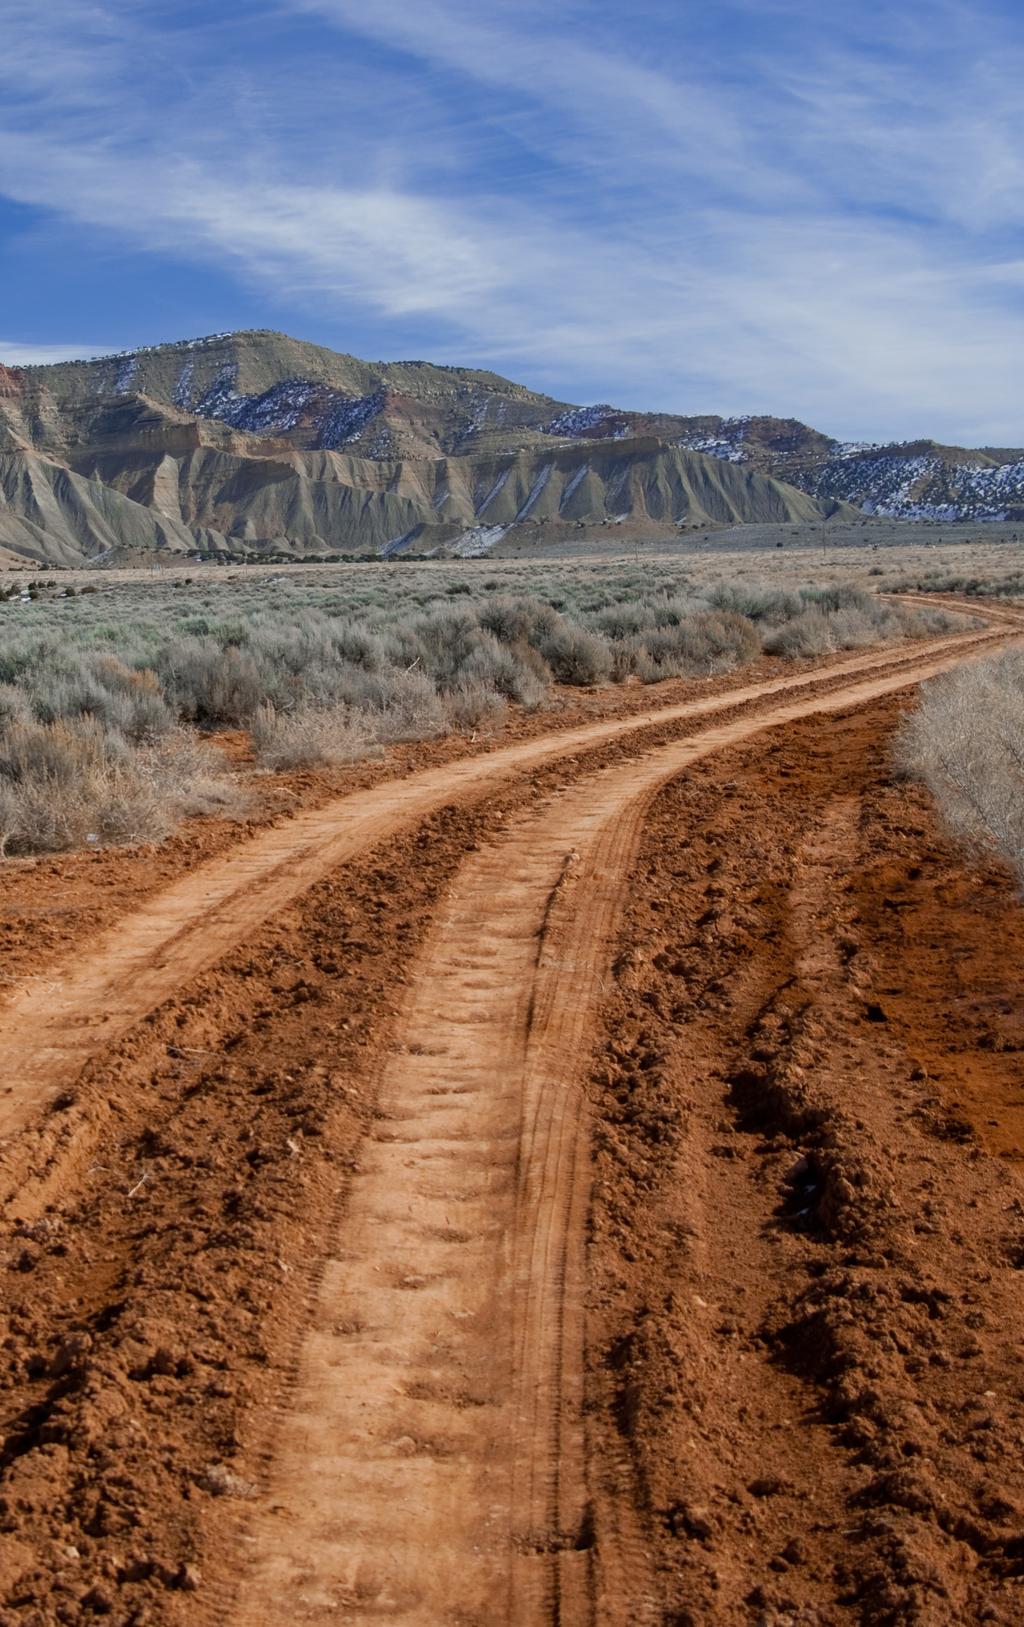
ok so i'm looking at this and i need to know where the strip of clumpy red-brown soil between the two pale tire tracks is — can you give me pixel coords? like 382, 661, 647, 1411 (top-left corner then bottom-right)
5, 608, 1015, 1627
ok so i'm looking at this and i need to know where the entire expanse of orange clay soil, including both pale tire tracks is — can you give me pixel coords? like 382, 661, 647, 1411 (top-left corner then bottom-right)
0, 611, 1024, 1627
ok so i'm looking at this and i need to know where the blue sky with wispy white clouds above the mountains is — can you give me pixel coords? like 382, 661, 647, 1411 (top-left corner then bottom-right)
0, 0, 1024, 446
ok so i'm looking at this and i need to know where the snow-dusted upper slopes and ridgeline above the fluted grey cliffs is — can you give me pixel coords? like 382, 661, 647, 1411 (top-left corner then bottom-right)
15, 330, 1024, 519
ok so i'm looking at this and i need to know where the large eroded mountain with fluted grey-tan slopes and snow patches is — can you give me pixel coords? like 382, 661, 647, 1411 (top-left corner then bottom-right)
0, 330, 842, 565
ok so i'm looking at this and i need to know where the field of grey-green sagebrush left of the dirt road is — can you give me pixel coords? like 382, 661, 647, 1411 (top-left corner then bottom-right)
0, 561, 956, 853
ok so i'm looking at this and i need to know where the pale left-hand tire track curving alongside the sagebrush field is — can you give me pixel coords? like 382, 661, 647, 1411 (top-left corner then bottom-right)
0, 612, 1017, 1173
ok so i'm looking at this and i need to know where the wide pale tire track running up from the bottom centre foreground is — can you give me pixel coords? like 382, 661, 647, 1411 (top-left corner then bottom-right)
215, 634, 1015, 1627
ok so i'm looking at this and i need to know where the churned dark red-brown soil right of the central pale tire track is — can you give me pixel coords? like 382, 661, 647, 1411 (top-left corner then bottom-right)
588, 703, 1024, 1627
